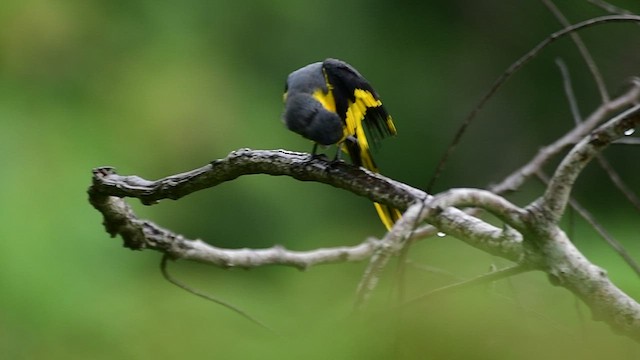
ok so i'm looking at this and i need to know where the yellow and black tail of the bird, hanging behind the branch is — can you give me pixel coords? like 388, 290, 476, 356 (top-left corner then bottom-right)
344, 135, 402, 231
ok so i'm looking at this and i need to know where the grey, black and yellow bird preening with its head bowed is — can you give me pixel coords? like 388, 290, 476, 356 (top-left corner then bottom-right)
282, 58, 402, 230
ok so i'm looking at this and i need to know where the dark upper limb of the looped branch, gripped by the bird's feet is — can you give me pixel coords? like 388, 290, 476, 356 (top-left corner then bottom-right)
90, 149, 426, 209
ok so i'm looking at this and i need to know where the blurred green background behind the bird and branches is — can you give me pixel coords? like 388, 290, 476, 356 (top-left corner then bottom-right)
0, 0, 640, 359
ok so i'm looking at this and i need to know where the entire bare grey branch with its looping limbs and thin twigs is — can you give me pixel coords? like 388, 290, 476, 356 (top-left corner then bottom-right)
88, 8, 640, 341
